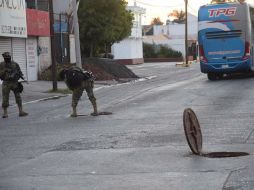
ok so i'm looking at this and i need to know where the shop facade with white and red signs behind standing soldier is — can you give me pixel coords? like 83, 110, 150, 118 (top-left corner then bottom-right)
0, 0, 51, 81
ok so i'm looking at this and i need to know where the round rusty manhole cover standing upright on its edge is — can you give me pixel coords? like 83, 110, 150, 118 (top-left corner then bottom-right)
183, 108, 202, 155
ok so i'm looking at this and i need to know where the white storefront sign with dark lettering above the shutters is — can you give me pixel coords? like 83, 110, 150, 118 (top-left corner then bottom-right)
0, 0, 27, 38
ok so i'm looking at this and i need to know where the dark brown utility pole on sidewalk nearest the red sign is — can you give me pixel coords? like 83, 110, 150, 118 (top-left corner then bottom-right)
49, 0, 57, 91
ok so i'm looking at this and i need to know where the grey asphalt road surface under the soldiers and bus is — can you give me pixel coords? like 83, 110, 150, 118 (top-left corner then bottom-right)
0, 63, 254, 190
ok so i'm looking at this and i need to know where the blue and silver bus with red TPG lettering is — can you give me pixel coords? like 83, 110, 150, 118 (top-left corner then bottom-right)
198, 0, 254, 80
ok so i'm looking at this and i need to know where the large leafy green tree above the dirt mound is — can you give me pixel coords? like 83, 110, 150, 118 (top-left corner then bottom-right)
78, 0, 134, 57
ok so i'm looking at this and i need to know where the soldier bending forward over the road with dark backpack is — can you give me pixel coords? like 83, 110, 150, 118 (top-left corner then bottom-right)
60, 67, 98, 117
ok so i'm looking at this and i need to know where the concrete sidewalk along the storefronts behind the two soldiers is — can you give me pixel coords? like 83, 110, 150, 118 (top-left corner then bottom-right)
0, 80, 117, 106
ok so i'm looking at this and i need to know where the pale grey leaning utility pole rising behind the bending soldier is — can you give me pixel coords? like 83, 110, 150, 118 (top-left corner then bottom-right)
72, 0, 82, 68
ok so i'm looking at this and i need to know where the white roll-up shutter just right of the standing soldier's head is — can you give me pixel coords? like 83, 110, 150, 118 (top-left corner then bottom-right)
12, 38, 27, 79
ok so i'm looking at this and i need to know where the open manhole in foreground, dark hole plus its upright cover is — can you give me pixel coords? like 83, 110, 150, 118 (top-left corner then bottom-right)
183, 108, 249, 158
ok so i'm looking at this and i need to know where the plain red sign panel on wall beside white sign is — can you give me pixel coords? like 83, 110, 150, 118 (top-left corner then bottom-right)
26, 9, 50, 36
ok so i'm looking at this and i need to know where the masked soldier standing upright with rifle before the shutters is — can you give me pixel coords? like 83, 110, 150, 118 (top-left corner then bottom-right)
0, 52, 28, 118
